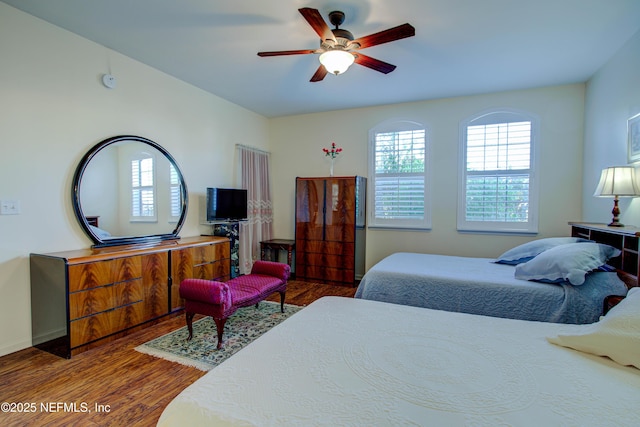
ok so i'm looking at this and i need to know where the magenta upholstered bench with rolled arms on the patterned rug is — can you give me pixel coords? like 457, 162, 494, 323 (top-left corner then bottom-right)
180, 261, 291, 348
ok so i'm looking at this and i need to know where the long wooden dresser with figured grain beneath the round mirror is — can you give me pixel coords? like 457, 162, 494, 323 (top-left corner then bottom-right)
30, 236, 230, 358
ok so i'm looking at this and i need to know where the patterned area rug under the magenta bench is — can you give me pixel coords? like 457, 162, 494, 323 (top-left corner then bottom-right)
136, 301, 303, 371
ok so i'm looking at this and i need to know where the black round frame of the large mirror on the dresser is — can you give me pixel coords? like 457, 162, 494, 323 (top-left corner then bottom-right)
71, 135, 189, 248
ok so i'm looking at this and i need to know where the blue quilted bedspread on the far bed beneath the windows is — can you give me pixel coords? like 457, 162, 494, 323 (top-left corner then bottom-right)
355, 253, 627, 324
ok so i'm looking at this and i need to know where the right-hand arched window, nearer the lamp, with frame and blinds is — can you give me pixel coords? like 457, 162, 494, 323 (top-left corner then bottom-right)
458, 109, 539, 233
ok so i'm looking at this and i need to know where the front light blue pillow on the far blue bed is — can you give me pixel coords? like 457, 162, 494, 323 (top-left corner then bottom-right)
515, 242, 620, 286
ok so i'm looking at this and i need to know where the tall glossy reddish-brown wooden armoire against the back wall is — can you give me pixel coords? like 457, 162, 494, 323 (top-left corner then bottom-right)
296, 176, 367, 286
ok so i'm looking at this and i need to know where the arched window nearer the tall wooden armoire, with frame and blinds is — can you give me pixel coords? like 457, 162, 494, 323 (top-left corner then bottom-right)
367, 121, 431, 229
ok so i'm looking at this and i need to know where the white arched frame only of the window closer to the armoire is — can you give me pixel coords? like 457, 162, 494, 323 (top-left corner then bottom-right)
367, 119, 431, 230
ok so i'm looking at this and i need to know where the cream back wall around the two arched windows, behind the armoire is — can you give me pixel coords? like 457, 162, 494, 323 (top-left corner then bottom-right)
270, 84, 585, 268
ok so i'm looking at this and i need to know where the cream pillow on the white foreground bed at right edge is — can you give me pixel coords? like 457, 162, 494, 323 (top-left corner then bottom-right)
547, 287, 640, 369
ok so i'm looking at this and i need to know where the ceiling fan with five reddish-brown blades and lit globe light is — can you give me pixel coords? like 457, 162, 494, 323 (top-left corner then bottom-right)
258, 7, 416, 82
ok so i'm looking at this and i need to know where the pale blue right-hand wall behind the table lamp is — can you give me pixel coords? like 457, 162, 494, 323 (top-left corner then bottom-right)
583, 32, 640, 226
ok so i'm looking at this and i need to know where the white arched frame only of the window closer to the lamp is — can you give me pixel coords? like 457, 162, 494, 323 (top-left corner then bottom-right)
457, 108, 540, 235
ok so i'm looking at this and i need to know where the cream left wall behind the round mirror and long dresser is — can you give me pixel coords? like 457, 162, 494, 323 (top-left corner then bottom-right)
0, 3, 268, 355
